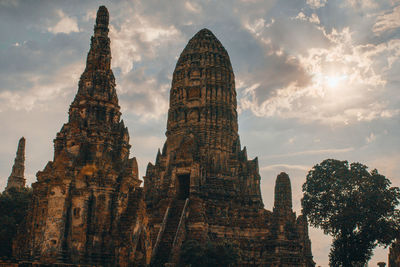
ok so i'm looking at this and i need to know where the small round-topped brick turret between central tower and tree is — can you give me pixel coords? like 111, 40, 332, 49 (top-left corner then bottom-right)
274, 172, 292, 214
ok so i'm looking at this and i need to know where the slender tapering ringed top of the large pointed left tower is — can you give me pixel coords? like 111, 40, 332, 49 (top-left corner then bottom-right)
69, 6, 120, 125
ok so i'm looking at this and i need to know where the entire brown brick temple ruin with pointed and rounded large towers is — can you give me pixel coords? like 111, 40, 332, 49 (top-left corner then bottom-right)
14, 6, 315, 267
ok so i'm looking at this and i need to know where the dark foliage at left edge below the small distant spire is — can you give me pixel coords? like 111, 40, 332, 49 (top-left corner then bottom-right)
0, 188, 32, 258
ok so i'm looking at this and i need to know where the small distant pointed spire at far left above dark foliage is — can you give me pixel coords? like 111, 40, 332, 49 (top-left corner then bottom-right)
6, 137, 25, 190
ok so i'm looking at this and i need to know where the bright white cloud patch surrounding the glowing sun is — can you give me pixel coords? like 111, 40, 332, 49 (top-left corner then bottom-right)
239, 26, 400, 124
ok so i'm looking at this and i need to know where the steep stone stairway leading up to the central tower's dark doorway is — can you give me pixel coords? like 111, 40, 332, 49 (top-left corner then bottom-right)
152, 199, 185, 266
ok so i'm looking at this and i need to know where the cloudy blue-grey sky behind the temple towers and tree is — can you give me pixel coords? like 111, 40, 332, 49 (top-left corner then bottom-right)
0, 0, 400, 266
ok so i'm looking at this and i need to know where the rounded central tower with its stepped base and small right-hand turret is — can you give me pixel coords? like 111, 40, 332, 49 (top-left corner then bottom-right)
144, 29, 314, 266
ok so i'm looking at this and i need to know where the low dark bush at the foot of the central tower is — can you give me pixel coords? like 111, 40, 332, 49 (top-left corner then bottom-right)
181, 240, 239, 267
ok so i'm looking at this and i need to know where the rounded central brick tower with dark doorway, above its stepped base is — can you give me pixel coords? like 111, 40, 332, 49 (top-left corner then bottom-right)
145, 29, 262, 208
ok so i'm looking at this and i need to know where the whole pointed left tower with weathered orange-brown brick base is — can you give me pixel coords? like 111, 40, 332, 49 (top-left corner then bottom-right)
16, 6, 151, 266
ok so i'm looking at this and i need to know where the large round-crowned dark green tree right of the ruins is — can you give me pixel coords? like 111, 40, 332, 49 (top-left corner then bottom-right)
302, 159, 400, 267
